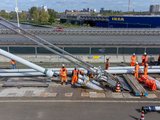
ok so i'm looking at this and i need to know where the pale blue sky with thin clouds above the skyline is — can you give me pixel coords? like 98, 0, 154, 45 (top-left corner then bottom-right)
0, 0, 160, 11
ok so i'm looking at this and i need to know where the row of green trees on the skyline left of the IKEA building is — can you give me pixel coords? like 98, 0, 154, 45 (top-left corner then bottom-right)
0, 7, 57, 24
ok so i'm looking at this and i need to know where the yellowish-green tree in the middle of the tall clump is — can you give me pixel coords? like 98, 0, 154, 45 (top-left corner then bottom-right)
39, 9, 49, 24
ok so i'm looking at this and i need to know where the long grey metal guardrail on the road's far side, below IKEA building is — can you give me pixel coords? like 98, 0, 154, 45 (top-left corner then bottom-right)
0, 29, 160, 35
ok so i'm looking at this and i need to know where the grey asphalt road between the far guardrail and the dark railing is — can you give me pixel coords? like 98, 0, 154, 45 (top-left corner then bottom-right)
0, 35, 160, 46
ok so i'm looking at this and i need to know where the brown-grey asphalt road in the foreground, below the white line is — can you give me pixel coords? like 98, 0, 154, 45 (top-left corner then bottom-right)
0, 100, 160, 120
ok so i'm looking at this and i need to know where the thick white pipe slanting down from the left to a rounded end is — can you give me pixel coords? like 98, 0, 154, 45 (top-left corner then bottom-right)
0, 49, 54, 77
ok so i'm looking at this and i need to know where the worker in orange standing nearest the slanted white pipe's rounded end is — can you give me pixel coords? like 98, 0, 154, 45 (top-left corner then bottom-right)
60, 64, 68, 85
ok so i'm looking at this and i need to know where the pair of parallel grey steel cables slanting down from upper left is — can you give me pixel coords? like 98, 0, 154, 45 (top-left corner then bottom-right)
0, 17, 114, 79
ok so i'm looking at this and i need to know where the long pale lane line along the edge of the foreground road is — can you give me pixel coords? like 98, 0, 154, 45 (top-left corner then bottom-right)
0, 100, 160, 103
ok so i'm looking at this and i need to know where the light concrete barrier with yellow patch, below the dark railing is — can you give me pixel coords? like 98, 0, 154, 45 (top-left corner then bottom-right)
0, 54, 158, 63
